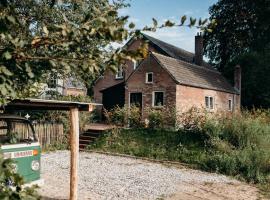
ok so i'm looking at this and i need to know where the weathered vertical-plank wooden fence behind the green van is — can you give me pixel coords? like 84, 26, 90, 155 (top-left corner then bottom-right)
0, 123, 64, 148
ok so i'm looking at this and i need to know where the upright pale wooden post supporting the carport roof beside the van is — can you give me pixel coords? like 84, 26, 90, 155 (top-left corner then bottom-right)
70, 108, 79, 200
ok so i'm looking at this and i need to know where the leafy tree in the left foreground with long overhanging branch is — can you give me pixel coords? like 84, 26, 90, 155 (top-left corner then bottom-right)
0, 0, 207, 102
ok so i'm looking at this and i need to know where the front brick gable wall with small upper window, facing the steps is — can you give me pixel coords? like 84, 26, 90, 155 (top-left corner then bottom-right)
125, 56, 176, 117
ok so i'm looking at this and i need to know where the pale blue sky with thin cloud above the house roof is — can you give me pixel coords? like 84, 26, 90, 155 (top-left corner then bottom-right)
119, 0, 217, 52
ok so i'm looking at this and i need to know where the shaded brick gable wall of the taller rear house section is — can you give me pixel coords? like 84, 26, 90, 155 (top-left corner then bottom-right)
94, 39, 162, 103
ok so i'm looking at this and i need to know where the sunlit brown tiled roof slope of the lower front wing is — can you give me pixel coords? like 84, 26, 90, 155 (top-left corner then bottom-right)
151, 53, 239, 93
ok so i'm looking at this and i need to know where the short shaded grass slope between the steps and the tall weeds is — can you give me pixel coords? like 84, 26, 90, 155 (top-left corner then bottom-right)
89, 129, 204, 160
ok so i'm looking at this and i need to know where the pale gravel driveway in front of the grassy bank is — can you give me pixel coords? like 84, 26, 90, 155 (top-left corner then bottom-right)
40, 151, 262, 200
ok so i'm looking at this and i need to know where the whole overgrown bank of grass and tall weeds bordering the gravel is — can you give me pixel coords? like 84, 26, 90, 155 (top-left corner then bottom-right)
89, 109, 270, 194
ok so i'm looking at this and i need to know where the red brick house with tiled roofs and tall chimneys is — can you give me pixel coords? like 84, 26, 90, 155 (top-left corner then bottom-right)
94, 34, 241, 116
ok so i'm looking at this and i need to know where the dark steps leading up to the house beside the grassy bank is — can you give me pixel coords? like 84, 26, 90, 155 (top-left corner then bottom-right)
79, 123, 113, 151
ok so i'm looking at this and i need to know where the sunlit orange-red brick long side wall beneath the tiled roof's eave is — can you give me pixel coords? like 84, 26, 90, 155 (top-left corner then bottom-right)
176, 85, 240, 112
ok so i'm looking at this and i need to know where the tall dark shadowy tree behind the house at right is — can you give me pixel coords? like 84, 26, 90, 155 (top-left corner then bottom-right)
204, 0, 270, 107
